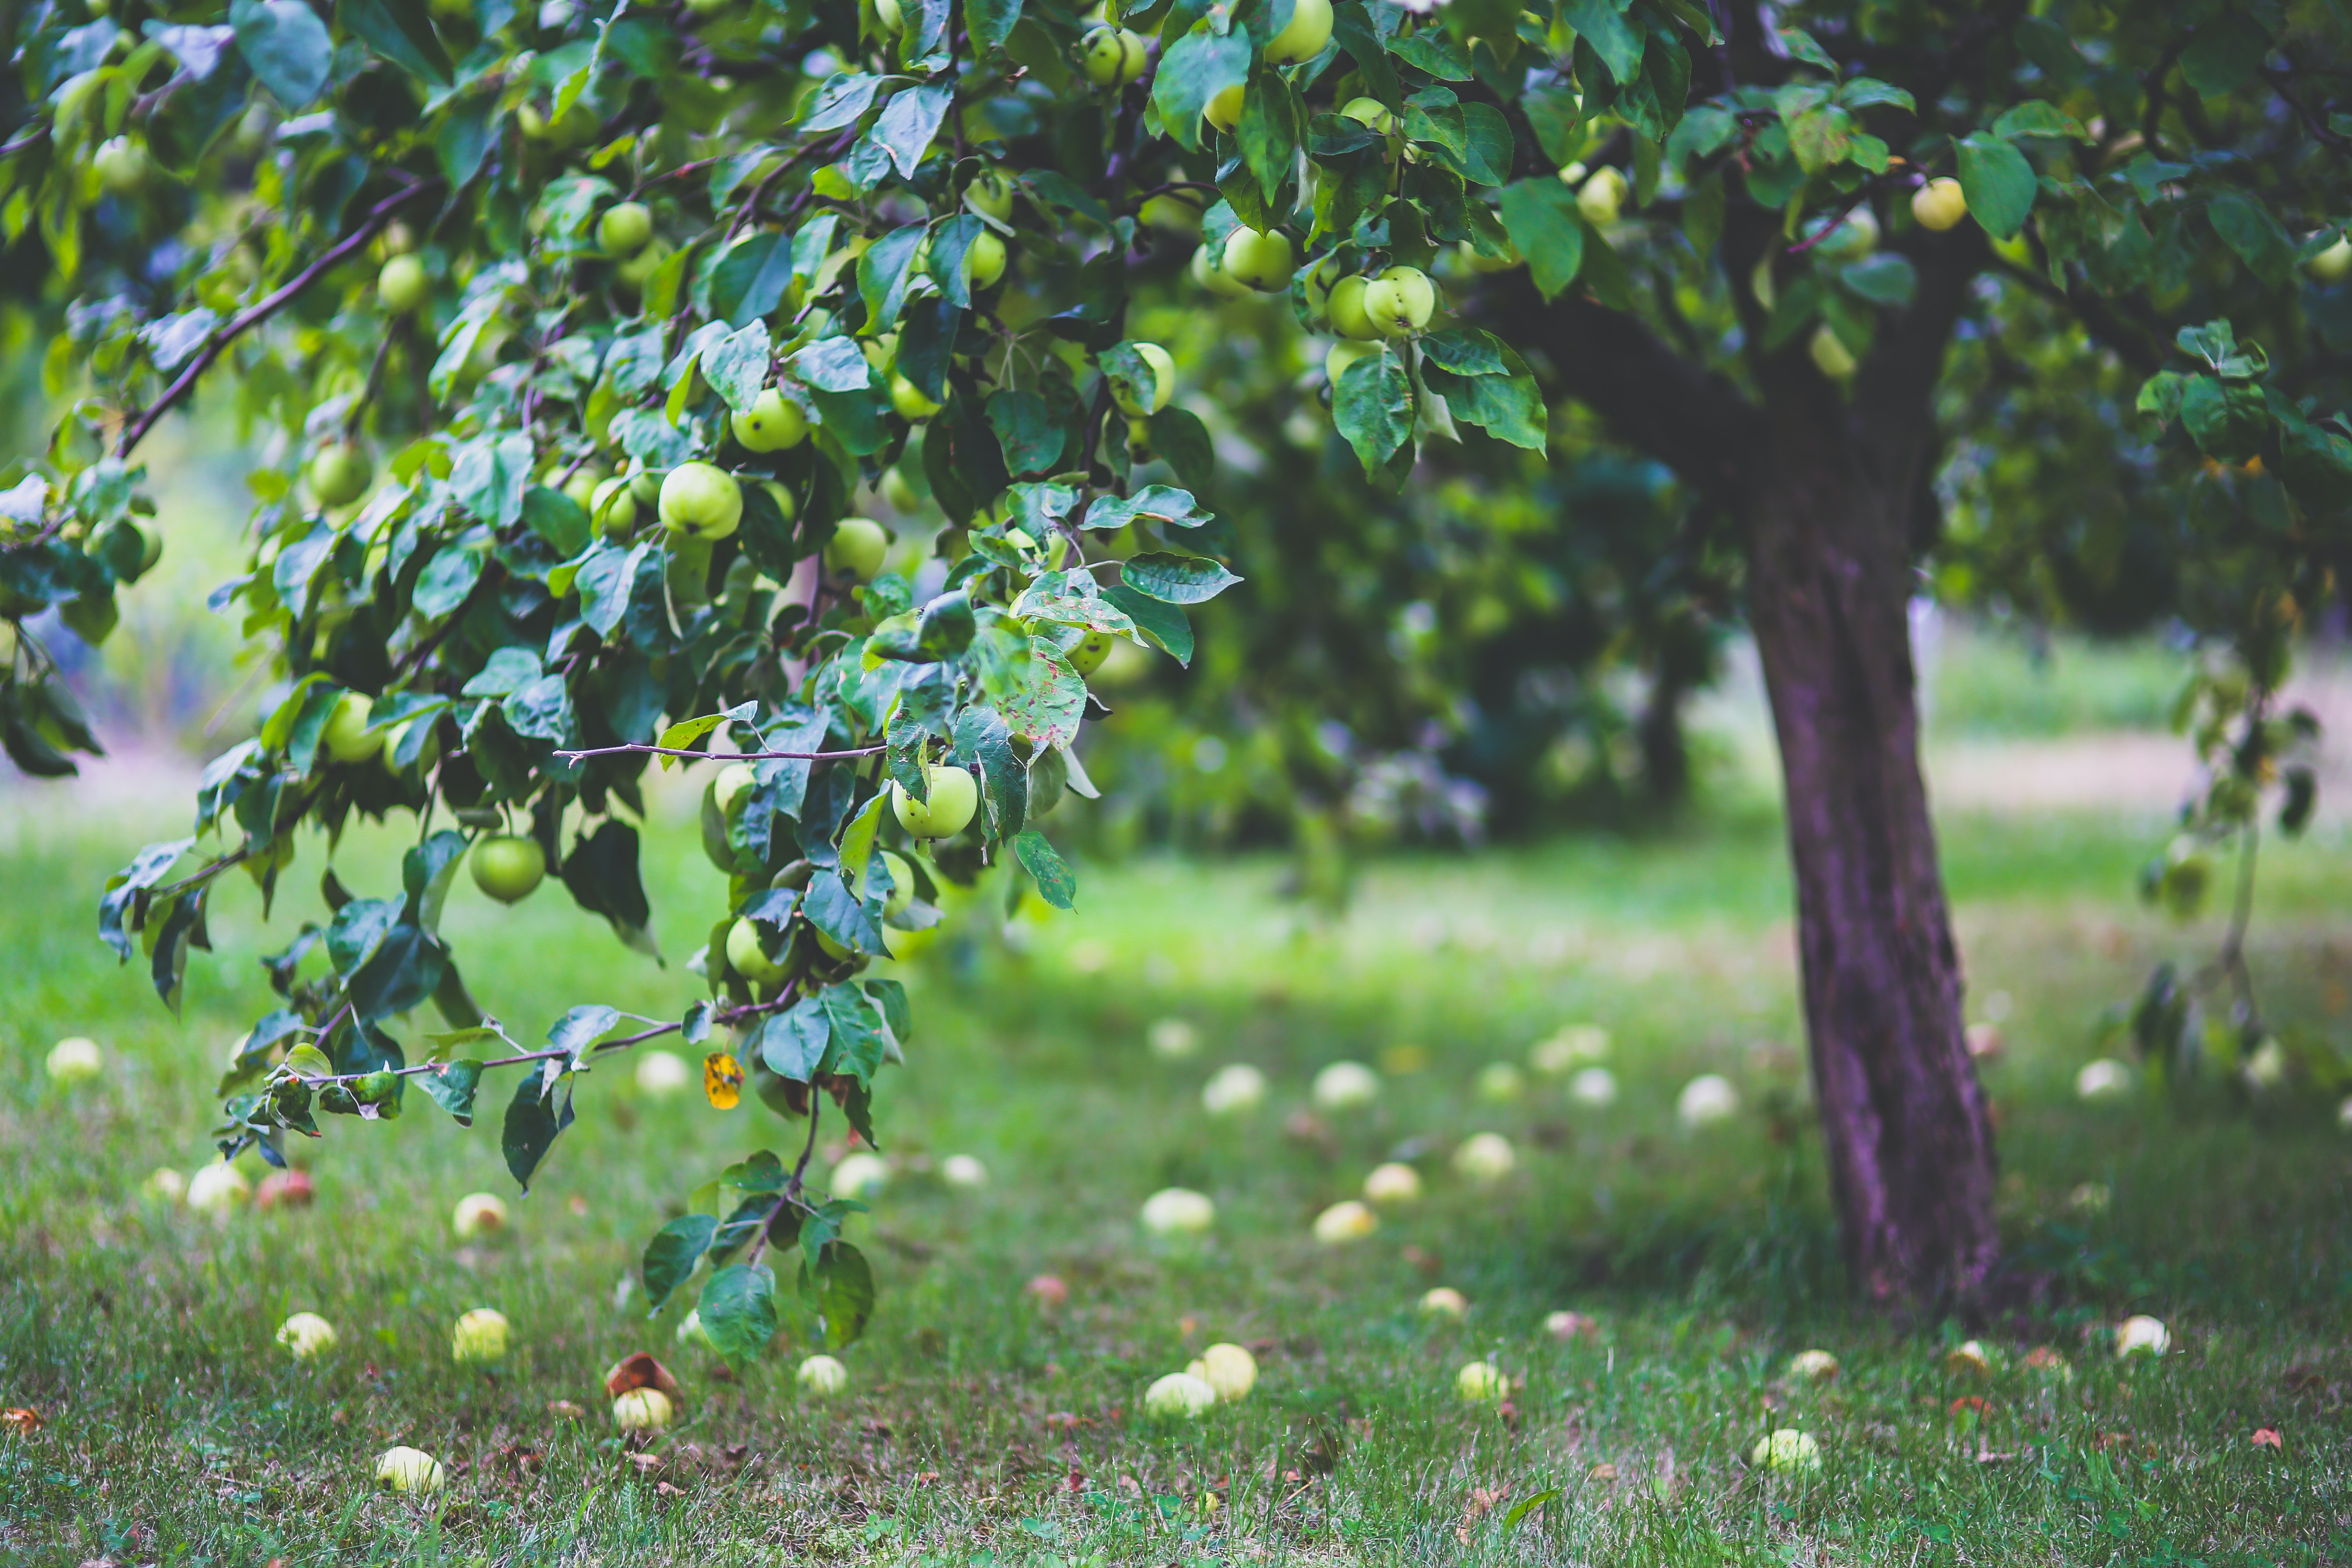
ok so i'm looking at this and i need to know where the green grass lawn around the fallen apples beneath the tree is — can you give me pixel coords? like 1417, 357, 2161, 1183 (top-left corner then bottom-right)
0, 797, 2352, 1568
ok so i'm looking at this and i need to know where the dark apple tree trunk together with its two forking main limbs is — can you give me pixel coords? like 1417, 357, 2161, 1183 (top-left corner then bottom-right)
1494, 227, 1999, 1309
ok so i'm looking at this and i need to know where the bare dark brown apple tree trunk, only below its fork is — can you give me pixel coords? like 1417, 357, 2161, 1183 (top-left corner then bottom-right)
1748, 470, 1999, 1305
